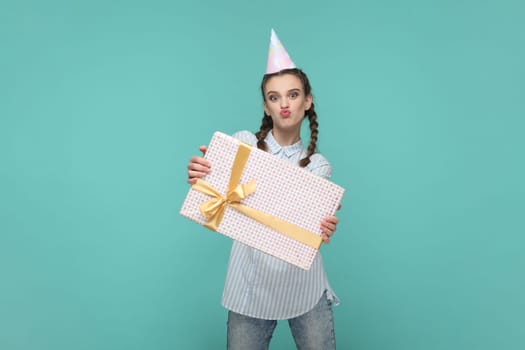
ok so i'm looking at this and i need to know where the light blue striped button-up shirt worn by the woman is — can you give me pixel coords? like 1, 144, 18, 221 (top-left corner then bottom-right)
222, 131, 339, 320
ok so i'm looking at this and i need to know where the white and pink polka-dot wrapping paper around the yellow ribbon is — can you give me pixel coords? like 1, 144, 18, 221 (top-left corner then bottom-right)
180, 132, 345, 270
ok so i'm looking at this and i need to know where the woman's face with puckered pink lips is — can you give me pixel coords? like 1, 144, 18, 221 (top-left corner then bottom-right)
264, 74, 312, 132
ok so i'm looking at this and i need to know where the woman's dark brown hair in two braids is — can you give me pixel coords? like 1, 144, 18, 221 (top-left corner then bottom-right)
255, 68, 319, 168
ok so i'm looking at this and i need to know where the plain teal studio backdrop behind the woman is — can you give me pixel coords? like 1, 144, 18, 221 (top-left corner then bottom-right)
0, 0, 525, 350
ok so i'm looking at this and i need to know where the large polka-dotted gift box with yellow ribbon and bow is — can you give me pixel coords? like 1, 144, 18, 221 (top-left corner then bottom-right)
180, 132, 344, 270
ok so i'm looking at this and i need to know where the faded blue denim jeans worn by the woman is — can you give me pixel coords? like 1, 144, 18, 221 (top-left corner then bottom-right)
228, 293, 335, 350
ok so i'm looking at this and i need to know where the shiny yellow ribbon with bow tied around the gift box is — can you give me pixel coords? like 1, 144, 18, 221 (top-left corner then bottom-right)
192, 143, 322, 249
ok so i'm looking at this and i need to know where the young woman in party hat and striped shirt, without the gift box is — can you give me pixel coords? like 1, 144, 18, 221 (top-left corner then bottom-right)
188, 30, 338, 350
